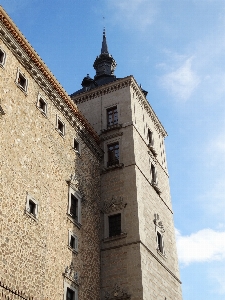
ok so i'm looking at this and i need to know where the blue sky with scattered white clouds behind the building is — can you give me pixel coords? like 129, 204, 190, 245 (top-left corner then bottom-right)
0, 0, 225, 300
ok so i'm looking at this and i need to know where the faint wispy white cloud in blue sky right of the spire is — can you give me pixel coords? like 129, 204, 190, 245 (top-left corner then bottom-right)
160, 57, 200, 100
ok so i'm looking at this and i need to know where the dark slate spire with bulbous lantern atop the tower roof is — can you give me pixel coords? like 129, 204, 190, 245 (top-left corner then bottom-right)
93, 29, 116, 80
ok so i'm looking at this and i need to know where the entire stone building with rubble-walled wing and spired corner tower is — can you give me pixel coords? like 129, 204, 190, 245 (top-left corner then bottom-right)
0, 4, 182, 300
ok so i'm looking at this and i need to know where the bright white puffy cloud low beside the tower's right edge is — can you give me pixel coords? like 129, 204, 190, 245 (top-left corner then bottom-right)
176, 229, 225, 265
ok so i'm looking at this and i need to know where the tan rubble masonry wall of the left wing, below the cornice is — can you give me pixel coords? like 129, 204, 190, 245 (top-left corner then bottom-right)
0, 37, 100, 300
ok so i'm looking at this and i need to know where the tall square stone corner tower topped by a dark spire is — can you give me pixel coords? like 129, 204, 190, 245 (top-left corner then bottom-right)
71, 31, 182, 300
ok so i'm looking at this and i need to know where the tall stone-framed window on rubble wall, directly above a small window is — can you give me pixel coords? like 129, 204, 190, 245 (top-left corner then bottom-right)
68, 187, 81, 223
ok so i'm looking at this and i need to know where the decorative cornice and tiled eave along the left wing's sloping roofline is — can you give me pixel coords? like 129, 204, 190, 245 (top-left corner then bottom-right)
0, 6, 99, 143
